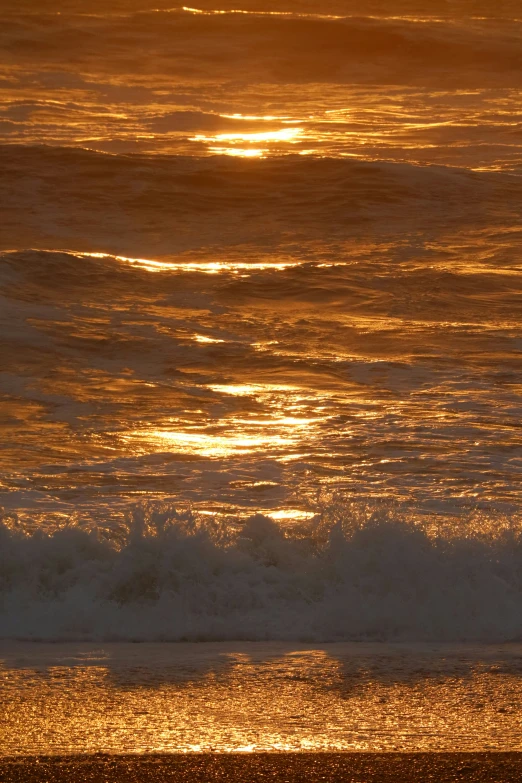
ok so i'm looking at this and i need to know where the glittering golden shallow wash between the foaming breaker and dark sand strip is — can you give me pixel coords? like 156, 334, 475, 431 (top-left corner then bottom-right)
0, 642, 522, 756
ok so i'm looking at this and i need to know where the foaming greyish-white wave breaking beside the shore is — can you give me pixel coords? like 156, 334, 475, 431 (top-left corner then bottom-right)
0, 508, 522, 642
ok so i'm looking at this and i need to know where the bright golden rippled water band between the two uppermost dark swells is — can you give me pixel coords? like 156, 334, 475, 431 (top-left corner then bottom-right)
5, 66, 522, 171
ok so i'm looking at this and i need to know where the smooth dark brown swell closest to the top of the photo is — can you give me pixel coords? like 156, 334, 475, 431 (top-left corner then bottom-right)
4, 9, 522, 86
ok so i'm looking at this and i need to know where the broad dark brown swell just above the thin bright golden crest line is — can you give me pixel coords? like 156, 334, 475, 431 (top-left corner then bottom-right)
0, 146, 522, 258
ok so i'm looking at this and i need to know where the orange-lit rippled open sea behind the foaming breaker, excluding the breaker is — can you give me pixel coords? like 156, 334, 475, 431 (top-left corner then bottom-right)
0, 0, 522, 544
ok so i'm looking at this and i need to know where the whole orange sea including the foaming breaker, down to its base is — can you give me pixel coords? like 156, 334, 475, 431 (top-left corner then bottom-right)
0, 0, 522, 643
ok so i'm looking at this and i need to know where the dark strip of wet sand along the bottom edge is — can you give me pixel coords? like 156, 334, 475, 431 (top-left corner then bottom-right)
0, 753, 522, 783
